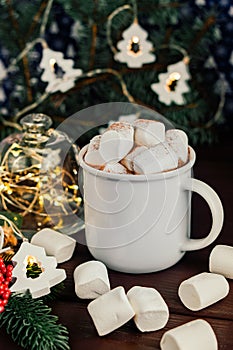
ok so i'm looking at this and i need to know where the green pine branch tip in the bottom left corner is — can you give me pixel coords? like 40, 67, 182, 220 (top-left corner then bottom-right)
0, 293, 70, 350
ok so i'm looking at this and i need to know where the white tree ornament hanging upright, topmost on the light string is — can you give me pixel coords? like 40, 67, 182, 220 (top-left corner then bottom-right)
114, 22, 155, 68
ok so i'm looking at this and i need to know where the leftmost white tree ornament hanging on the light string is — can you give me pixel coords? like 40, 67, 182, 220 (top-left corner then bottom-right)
40, 47, 82, 93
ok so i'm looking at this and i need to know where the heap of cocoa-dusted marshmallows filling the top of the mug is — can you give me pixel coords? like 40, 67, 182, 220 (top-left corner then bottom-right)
84, 119, 188, 174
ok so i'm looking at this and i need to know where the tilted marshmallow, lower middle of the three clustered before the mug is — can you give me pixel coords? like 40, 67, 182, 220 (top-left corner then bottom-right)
87, 287, 135, 336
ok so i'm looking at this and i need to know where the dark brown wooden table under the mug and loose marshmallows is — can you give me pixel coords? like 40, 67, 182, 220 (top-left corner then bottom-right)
0, 133, 233, 350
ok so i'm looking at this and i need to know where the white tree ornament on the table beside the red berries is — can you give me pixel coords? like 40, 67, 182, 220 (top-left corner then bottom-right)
10, 242, 66, 298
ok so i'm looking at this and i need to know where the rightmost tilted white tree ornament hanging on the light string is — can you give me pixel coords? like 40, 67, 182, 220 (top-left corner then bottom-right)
151, 61, 190, 105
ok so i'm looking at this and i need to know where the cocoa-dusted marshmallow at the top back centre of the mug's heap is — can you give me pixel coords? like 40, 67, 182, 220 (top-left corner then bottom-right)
134, 119, 165, 147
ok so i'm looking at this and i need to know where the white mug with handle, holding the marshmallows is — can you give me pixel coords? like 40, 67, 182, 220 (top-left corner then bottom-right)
79, 146, 223, 273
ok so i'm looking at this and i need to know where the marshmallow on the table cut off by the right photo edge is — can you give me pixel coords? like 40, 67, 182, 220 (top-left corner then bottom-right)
209, 245, 233, 279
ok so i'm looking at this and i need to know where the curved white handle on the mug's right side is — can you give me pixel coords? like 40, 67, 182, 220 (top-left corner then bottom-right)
181, 178, 224, 251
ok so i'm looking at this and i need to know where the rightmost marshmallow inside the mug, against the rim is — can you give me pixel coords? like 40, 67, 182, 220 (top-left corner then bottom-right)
165, 129, 188, 163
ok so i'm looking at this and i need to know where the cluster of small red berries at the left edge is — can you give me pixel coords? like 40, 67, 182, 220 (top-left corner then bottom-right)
0, 258, 13, 313
